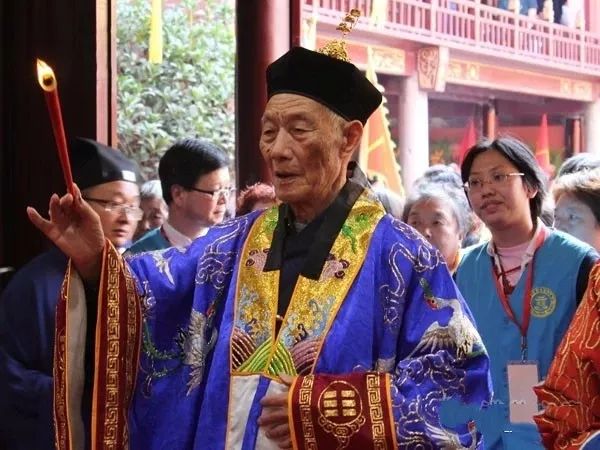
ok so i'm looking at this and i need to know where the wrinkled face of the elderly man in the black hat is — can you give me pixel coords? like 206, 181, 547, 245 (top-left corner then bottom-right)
260, 94, 346, 209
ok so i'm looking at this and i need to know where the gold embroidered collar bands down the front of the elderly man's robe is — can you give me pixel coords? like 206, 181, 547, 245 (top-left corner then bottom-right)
230, 191, 385, 377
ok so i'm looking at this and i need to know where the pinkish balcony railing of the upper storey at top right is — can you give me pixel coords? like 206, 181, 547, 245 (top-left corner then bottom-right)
303, 0, 600, 76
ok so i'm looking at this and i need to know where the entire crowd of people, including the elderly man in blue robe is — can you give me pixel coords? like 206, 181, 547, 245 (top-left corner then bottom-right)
0, 30, 600, 450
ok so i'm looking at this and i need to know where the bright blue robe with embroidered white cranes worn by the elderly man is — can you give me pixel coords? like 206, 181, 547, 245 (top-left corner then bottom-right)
129, 196, 491, 449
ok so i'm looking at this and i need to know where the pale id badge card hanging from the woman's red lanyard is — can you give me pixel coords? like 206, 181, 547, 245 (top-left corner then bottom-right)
506, 361, 539, 424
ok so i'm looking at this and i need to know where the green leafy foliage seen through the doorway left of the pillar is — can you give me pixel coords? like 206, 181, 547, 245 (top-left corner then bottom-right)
117, 0, 235, 177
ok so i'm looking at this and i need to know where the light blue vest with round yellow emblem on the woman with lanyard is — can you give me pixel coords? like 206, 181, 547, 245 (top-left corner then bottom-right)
456, 230, 591, 450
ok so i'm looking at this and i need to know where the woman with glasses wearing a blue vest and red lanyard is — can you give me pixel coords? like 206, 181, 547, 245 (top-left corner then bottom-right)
456, 138, 598, 450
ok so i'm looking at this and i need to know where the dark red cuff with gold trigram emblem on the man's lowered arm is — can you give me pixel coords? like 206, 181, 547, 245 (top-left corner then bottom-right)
289, 372, 397, 450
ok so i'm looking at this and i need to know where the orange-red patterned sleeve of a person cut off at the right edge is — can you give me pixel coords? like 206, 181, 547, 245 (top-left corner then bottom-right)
535, 264, 600, 450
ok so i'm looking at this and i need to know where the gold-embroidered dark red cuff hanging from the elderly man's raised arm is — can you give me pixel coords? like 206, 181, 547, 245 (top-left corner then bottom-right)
54, 241, 141, 450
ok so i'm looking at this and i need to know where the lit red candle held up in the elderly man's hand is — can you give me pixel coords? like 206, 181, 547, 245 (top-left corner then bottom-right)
37, 59, 73, 194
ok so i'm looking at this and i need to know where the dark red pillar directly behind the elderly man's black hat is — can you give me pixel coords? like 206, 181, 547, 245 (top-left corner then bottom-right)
236, 0, 300, 189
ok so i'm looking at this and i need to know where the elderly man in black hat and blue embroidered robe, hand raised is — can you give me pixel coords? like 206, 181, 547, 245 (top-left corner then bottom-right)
28, 18, 491, 449
